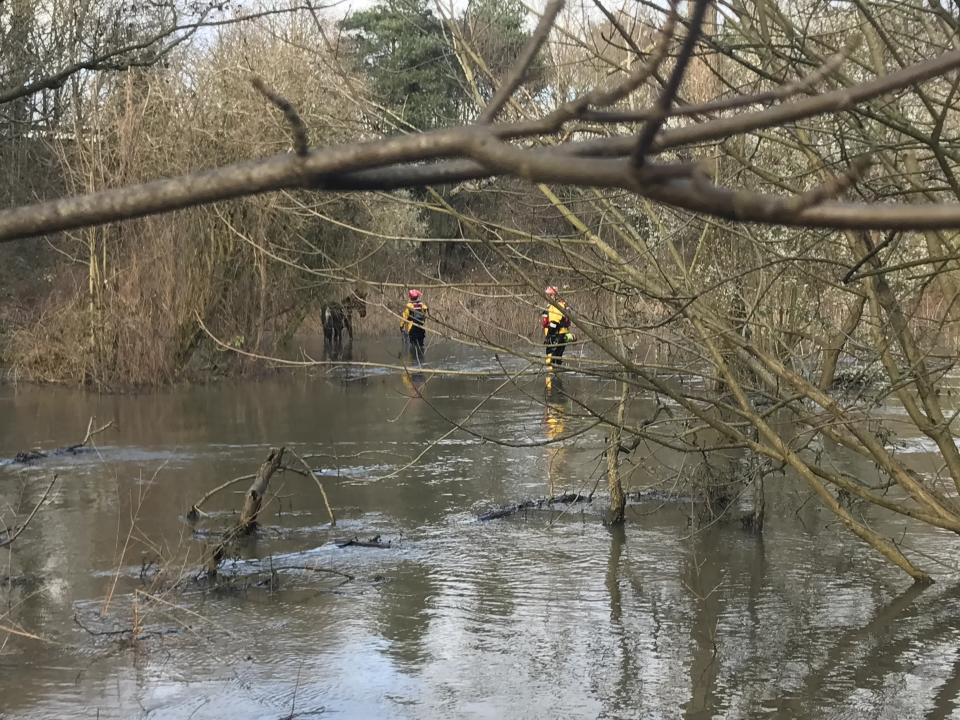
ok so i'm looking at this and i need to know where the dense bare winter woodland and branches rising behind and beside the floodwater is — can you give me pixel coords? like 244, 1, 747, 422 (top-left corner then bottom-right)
0, 0, 960, 580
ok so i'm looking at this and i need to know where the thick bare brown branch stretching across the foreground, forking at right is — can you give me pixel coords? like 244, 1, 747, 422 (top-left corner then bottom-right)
0, 43, 960, 236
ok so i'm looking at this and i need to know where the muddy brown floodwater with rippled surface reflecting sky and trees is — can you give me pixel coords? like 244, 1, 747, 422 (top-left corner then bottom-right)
0, 340, 960, 720
